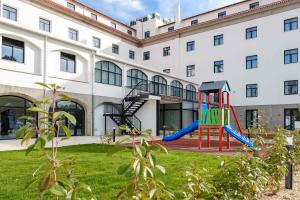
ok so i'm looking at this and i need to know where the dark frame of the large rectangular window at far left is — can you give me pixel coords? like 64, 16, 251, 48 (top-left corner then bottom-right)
1, 36, 25, 64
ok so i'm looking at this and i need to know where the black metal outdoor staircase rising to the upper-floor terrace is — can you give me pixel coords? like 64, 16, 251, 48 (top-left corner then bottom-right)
104, 81, 149, 130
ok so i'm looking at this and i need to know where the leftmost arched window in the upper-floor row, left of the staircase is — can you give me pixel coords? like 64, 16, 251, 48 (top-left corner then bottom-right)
95, 61, 122, 86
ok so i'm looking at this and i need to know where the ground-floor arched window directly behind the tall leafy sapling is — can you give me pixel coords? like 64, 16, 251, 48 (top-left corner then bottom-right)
56, 101, 85, 136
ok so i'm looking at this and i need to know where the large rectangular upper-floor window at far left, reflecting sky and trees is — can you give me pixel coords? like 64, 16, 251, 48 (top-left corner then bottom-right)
2, 37, 24, 63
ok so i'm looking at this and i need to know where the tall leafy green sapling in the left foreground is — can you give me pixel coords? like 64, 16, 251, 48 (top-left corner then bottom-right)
16, 83, 94, 200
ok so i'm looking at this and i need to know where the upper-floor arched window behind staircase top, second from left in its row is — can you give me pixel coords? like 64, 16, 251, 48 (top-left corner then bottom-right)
127, 69, 148, 91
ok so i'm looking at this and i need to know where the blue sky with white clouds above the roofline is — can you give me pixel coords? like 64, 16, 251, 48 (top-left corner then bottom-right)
79, 0, 241, 24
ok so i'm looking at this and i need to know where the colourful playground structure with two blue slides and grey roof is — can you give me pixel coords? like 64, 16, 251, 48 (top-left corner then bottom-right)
163, 81, 254, 151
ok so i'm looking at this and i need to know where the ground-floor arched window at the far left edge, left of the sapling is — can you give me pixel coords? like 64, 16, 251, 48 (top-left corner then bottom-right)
0, 96, 37, 139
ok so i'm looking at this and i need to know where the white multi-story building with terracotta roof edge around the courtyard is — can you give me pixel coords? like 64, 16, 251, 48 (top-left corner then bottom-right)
0, 0, 300, 139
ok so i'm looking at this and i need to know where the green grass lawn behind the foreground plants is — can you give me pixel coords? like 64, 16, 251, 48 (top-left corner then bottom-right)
0, 144, 230, 200
